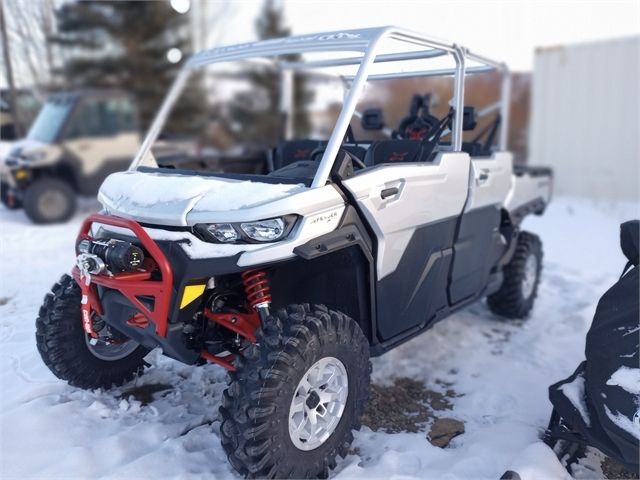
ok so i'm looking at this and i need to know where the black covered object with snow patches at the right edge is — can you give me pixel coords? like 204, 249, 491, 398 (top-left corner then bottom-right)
547, 220, 640, 471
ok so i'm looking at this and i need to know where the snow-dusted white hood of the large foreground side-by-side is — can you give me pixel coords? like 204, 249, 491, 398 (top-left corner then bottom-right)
98, 171, 306, 226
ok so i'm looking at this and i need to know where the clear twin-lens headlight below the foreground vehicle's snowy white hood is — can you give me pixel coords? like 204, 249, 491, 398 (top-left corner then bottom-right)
195, 215, 297, 243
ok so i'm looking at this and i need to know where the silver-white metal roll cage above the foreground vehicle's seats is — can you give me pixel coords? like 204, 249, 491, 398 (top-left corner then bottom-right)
129, 27, 511, 188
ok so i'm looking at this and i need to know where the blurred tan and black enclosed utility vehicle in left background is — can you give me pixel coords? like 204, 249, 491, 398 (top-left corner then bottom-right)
0, 90, 140, 223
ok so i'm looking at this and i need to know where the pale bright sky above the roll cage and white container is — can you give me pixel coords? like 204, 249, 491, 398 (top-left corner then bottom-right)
208, 0, 640, 71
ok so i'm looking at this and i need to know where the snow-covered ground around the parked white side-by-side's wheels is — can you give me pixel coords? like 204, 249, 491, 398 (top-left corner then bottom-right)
0, 198, 640, 479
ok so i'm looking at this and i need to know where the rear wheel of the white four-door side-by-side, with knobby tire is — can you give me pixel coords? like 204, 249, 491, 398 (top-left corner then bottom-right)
487, 232, 542, 319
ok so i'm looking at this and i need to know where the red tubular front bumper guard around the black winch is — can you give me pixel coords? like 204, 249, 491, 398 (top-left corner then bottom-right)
72, 213, 173, 337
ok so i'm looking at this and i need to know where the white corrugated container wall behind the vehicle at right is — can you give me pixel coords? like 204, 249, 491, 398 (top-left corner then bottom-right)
529, 37, 640, 202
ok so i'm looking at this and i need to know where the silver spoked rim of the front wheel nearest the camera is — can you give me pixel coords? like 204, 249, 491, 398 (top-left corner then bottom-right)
289, 357, 349, 451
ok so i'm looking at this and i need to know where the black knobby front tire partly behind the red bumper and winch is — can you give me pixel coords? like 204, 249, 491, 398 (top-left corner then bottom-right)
36, 275, 148, 389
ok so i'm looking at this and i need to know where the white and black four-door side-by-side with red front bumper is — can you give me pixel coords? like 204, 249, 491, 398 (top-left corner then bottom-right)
36, 27, 552, 478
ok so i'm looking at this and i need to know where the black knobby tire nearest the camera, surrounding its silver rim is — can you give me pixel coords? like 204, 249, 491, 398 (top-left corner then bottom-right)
220, 305, 371, 478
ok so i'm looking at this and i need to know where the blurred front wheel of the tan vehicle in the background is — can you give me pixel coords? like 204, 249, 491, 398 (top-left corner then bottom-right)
23, 178, 76, 224
